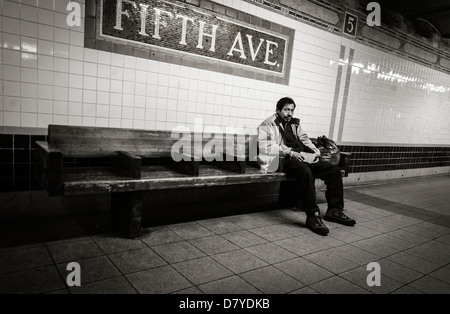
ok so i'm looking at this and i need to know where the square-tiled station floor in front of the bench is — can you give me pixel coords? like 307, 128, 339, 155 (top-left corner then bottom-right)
0, 176, 450, 294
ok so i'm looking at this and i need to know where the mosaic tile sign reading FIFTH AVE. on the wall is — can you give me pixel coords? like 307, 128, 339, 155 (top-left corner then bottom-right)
87, 0, 293, 83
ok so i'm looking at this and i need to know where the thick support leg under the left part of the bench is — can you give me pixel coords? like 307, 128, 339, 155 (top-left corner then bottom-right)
111, 191, 142, 238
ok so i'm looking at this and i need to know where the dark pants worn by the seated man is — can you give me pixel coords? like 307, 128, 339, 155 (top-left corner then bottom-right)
283, 158, 344, 216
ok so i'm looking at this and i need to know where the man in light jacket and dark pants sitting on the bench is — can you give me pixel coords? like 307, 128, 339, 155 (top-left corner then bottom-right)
258, 97, 356, 235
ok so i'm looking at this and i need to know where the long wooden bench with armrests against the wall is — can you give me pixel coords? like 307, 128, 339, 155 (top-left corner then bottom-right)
35, 125, 350, 237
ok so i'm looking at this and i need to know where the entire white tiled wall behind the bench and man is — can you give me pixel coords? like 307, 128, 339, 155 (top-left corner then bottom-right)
0, 0, 450, 144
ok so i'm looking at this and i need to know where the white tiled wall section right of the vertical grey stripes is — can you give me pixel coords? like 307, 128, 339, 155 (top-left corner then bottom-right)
343, 45, 450, 144
